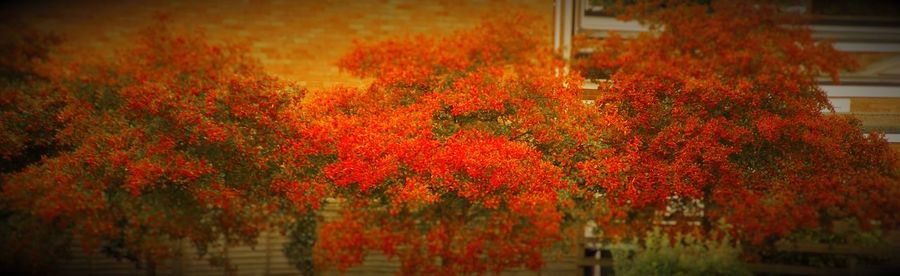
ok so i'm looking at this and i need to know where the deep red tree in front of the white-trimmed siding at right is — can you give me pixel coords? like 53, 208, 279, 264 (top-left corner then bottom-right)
576, 1, 900, 244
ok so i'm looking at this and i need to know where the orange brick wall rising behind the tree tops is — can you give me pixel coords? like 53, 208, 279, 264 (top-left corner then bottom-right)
6, 0, 553, 88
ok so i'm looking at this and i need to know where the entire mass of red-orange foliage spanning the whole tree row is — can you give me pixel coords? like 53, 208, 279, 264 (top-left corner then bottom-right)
0, 1, 900, 275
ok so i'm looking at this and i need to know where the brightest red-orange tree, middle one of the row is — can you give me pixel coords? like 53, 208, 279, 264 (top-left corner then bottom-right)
304, 16, 592, 274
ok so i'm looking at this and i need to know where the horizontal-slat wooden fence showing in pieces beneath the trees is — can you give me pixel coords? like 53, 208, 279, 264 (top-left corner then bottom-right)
52, 202, 900, 276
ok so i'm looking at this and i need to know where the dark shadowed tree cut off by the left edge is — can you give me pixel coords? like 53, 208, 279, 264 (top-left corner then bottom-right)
0, 18, 69, 274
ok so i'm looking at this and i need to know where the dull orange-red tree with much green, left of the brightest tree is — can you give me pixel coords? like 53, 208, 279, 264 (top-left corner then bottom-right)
2, 23, 325, 271
